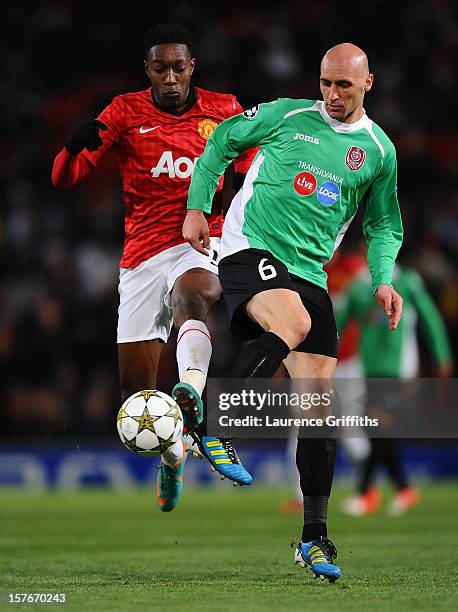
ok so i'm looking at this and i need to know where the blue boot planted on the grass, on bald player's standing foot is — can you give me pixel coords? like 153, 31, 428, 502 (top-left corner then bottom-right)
294, 536, 342, 582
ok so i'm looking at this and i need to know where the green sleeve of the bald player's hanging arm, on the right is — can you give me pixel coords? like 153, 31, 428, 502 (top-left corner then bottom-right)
363, 147, 403, 293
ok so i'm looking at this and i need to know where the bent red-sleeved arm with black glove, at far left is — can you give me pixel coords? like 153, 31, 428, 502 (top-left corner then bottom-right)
51, 98, 121, 188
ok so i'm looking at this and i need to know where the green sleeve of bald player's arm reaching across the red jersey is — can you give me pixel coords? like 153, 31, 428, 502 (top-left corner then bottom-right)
188, 100, 282, 213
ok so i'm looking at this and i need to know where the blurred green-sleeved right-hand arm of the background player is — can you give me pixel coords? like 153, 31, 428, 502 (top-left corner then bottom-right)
405, 270, 453, 377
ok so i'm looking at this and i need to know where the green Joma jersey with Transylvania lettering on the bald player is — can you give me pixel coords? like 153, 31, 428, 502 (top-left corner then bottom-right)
188, 98, 402, 290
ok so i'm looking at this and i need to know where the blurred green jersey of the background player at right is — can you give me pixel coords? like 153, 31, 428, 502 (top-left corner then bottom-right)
336, 266, 452, 378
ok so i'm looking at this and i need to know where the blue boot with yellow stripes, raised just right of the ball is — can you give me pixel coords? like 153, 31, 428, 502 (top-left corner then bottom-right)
186, 431, 253, 485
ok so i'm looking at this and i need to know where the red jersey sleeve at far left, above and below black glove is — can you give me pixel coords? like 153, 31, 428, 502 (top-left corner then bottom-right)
51, 97, 124, 188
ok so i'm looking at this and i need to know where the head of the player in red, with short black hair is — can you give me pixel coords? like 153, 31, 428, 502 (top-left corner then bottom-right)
145, 24, 196, 109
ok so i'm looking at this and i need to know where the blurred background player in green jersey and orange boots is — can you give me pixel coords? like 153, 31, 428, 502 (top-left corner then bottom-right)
336, 265, 453, 516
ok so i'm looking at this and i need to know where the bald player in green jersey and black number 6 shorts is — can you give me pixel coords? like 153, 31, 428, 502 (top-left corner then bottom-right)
183, 43, 403, 581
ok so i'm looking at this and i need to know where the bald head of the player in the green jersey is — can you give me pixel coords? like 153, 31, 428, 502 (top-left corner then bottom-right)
320, 43, 374, 123
